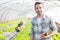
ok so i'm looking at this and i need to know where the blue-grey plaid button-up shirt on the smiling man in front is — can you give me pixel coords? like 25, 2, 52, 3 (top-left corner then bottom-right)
30, 16, 57, 40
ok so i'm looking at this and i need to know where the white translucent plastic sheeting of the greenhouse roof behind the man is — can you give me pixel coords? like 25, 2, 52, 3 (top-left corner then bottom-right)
0, 0, 60, 22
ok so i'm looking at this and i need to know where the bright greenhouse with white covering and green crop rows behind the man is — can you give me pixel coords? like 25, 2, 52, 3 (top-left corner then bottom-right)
0, 0, 60, 40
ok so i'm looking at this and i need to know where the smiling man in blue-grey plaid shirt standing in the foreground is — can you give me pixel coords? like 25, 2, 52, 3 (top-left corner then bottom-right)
30, 2, 57, 40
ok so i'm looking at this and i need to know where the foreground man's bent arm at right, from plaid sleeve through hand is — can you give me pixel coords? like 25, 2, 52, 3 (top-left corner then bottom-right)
41, 20, 57, 38
